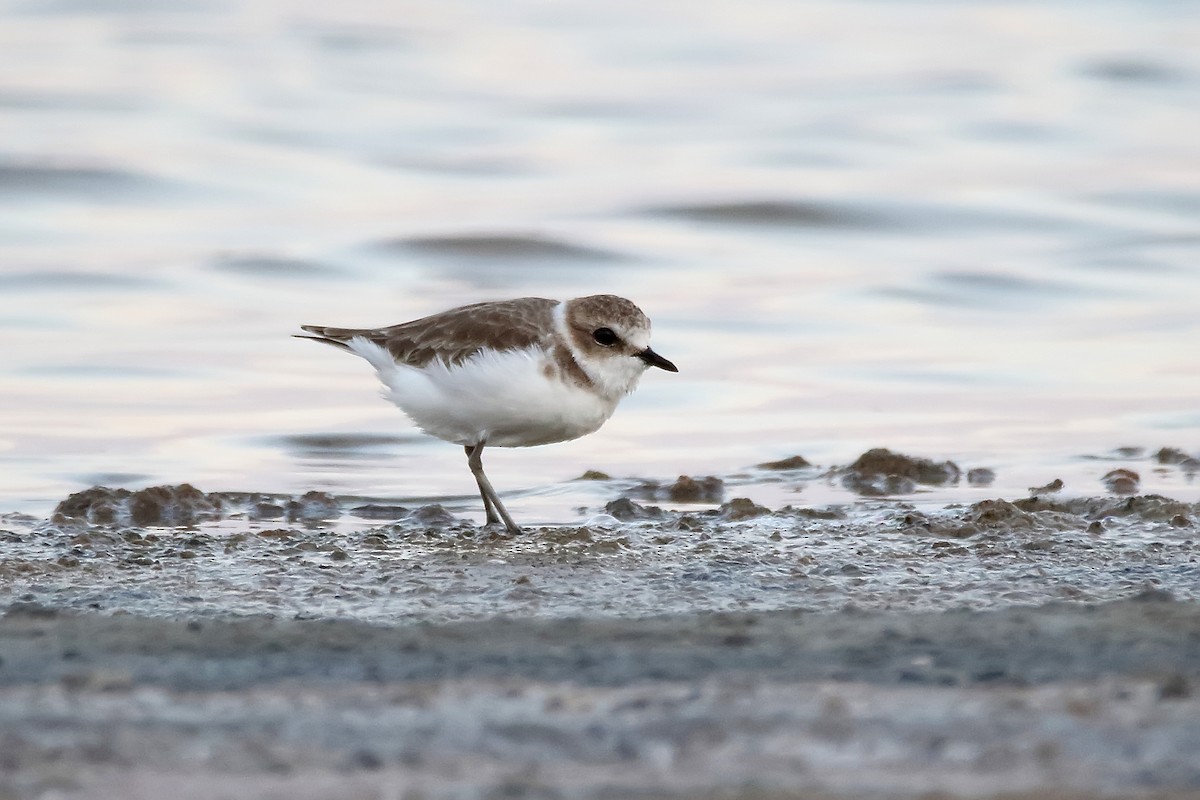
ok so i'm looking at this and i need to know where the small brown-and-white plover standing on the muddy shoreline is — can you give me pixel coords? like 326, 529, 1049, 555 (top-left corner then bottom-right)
295, 294, 679, 534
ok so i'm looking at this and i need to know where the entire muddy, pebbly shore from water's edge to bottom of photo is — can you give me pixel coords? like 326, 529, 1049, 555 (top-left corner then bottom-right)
0, 453, 1200, 800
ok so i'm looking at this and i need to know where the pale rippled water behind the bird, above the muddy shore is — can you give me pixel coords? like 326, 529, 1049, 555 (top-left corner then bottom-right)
0, 0, 1200, 521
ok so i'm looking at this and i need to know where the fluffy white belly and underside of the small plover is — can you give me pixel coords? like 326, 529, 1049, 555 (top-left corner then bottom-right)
349, 339, 617, 447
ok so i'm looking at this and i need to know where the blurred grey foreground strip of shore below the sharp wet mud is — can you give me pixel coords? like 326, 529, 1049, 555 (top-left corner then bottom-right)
0, 591, 1200, 800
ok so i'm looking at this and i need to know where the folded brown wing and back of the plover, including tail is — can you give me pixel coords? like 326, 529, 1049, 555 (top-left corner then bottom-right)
300, 297, 558, 367
